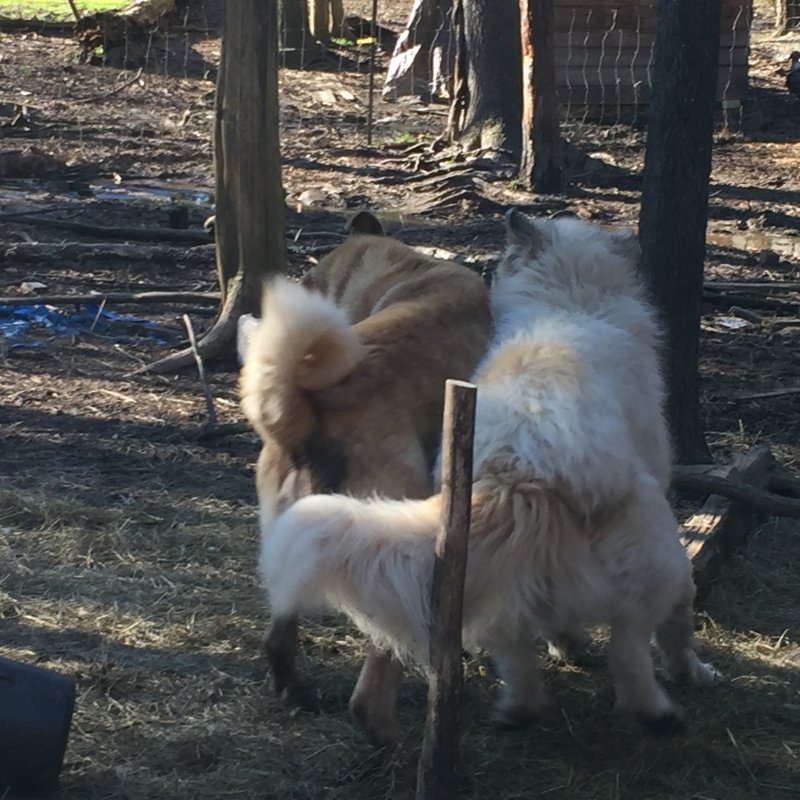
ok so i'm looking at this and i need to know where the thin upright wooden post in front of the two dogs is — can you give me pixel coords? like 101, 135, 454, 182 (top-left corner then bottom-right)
416, 380, 477, 800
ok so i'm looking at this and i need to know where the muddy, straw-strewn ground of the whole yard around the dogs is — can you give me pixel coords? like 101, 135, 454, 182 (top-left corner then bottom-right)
0, 0, 800, 800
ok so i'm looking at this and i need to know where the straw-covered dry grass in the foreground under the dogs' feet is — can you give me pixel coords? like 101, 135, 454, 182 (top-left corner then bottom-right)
0, 462, 800, 800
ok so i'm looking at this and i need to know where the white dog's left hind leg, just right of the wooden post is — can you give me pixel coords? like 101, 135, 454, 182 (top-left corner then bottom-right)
483, 631, 547, 729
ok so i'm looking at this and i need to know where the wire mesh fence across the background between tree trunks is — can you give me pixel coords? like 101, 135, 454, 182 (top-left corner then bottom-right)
0, 0, 776, 195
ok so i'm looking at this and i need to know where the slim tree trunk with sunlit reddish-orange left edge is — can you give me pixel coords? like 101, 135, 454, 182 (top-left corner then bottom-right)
520, 0, 561, 192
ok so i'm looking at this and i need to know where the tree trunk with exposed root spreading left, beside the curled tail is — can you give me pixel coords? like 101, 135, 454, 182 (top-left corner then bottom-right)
145, 0, 286, 372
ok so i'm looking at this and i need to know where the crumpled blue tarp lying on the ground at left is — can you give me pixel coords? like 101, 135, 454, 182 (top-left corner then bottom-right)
0, 303, 166, 349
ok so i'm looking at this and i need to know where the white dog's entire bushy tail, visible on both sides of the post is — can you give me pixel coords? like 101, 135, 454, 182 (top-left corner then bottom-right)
260, 472, 572, 664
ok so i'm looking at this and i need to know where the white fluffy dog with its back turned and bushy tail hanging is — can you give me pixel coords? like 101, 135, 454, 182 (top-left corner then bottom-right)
255, 211, 715, 730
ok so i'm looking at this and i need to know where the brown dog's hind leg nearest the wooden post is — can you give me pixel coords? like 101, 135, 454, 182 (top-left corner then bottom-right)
350, 645, 403, 747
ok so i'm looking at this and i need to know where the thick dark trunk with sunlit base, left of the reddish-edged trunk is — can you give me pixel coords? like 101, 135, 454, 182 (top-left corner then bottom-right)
461, 0, 522, 158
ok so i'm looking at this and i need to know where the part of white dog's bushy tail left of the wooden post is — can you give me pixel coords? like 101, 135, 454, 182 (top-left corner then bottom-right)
260, 495, 441, 663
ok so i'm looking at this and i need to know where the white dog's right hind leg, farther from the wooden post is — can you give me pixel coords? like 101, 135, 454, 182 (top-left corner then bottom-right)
608, 619, 684, 734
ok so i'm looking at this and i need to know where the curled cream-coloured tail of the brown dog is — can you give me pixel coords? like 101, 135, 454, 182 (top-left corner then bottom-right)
240, 279, 364, 439
